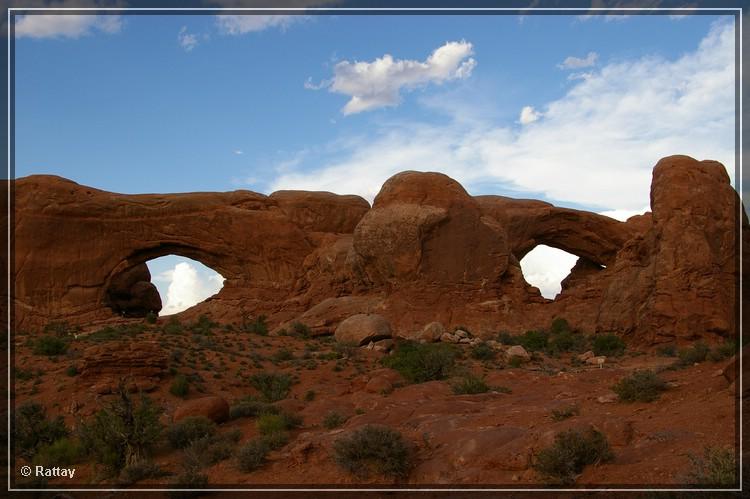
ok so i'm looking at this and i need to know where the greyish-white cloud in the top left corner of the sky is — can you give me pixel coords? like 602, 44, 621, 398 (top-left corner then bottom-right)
15, 14, 122, 38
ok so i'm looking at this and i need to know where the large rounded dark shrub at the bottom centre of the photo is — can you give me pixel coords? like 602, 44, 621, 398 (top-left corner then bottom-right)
333, 425, 412, 478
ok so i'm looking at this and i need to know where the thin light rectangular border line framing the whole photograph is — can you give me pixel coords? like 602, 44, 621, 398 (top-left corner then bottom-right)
7, 7, 743, 492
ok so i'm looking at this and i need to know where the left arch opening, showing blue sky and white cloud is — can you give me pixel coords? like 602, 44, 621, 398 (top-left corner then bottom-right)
146, 255, 225, 316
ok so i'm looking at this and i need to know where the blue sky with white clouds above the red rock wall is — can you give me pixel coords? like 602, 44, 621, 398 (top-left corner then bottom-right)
15, 15, 735, 308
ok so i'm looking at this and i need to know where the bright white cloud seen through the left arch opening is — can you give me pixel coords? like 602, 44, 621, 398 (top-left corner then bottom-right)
160, 262, 224, 315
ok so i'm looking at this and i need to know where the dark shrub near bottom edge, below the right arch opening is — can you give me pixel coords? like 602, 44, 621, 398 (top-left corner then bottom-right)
534, 428, 613, 484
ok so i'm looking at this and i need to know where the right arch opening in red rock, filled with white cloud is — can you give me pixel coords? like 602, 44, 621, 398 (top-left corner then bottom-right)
520, 244, 578, 300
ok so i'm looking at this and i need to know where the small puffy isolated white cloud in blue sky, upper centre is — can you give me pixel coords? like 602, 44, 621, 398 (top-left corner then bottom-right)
305, 40, 476, 114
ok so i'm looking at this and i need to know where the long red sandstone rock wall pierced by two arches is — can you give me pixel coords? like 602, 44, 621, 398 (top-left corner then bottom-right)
13, 156, 750, 344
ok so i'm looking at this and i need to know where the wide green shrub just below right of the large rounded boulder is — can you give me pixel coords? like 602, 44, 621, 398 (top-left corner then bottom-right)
382, 341, 457, 383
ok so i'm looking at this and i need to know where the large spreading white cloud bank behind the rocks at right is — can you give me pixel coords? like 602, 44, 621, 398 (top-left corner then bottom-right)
271, 19, 735, 210
